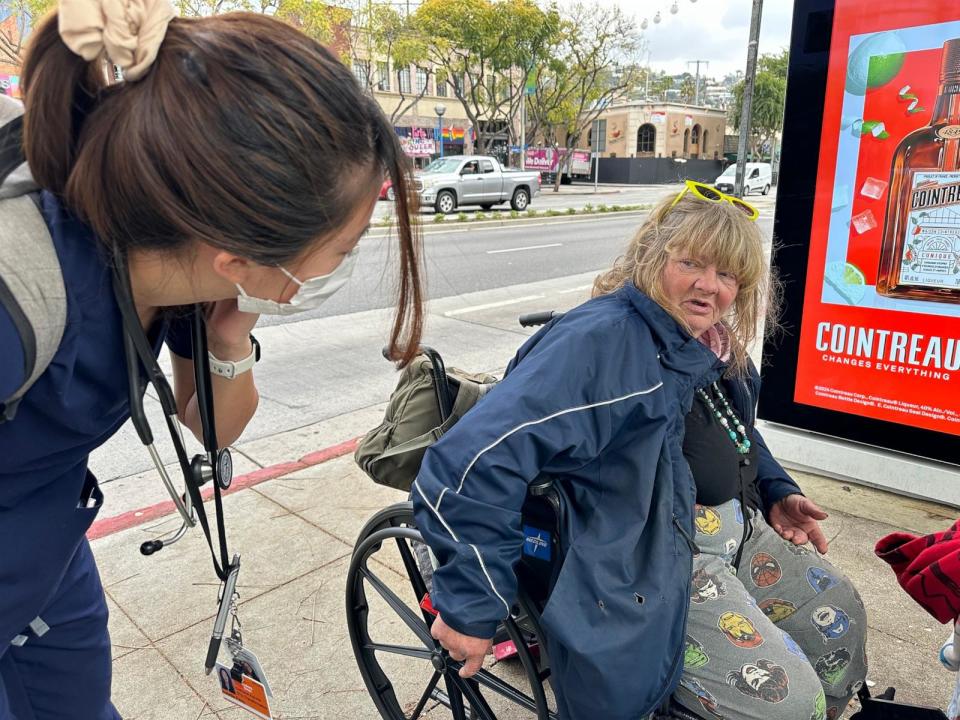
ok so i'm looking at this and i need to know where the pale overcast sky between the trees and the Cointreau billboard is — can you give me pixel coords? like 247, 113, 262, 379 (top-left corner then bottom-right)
618, 0, 793, 78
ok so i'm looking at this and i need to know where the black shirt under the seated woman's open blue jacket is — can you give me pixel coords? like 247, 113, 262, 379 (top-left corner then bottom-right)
683, 384, 760, 510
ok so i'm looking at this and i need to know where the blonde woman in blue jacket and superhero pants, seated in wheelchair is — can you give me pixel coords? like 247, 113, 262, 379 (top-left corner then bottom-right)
413, 182, 866, 720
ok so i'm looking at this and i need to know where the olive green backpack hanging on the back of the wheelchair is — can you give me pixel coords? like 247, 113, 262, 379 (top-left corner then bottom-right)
353, 347, 497, 492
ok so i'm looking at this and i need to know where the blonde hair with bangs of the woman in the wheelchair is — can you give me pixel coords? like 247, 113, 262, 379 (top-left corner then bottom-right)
592, 193, 779, 372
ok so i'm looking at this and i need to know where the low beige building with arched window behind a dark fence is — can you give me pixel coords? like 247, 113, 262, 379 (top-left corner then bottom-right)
584, 101, 727, 160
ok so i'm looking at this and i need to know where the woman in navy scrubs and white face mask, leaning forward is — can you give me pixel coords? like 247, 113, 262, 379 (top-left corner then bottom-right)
0, 0, 422, 720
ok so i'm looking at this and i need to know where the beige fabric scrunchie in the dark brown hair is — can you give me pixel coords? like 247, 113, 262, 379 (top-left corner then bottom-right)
59, 0, 174, 80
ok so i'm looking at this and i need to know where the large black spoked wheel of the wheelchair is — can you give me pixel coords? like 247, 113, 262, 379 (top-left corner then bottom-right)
346, 503, 557, 720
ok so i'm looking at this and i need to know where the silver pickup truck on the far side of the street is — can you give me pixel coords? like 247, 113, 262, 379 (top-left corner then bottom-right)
416, 155, 540, 215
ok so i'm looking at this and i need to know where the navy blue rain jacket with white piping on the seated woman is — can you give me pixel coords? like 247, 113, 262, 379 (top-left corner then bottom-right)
413, 285, 800, 720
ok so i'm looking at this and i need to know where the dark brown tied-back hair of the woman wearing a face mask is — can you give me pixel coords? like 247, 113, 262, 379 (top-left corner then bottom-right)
21, 13, 423, 364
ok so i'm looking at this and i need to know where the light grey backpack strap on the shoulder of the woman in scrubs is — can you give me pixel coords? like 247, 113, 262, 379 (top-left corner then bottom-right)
0, 95, 67, 423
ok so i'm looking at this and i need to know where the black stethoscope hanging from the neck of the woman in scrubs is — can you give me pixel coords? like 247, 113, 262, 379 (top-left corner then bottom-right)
113, 253, 240, 673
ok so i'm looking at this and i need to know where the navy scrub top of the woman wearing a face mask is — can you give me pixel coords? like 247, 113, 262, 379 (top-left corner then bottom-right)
0, 192, 191, 509
